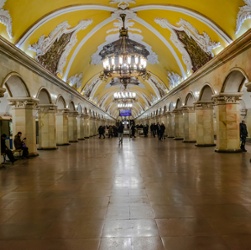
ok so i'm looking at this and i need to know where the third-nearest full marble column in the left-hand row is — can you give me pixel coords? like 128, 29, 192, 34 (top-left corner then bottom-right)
56, 109, 70, 146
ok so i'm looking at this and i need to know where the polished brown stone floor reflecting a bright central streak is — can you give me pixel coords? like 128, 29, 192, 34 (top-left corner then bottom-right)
0, 137, 251, 250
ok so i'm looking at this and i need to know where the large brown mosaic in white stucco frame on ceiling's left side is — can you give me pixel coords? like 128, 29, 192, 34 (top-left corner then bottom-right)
29, 20, 92, 75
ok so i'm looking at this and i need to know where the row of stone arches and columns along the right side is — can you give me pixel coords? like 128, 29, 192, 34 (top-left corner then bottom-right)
137, 69, 251, 152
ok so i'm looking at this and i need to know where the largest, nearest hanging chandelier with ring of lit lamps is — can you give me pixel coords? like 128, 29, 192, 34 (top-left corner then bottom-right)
99, 14, 149, 80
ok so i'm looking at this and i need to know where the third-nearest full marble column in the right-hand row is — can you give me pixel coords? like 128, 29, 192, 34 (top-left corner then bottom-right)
182, 106, 196, 143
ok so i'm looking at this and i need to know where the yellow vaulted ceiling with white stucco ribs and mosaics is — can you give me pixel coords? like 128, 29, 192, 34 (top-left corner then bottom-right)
0, 0, 251, 117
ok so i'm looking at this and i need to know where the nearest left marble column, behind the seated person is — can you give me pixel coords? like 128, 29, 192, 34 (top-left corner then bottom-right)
8, 97, 39, 156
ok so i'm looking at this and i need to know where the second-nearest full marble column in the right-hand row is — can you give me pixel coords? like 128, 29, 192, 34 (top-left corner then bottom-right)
195, 102, 215, 147
